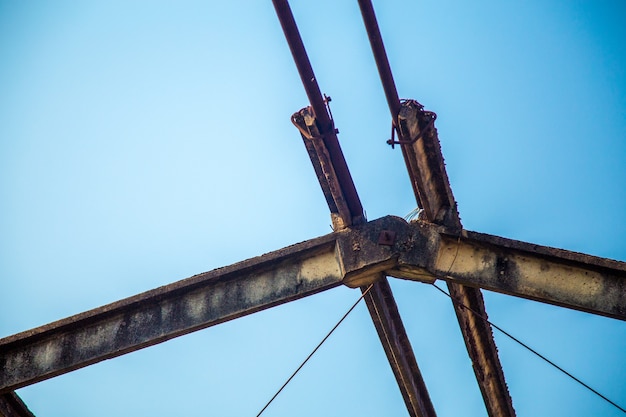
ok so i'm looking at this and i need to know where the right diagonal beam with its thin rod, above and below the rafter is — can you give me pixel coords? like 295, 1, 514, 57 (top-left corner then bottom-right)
359, 0, 515, 417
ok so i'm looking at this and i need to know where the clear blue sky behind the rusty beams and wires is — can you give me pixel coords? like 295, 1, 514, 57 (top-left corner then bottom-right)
0, 0, 626, 417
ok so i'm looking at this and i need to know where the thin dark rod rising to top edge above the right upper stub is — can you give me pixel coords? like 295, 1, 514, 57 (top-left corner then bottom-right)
358, 0, 400, 118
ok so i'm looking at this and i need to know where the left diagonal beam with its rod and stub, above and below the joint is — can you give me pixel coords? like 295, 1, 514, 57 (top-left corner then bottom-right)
273, 0, 435, 417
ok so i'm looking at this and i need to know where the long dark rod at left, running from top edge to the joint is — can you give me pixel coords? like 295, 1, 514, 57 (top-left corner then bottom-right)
273, 0, 365, 226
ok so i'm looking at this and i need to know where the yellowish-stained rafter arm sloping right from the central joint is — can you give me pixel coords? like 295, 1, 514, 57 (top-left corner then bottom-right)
431, 232, 626, 320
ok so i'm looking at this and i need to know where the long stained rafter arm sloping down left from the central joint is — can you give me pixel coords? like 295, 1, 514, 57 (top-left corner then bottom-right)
0, 229, 343, 393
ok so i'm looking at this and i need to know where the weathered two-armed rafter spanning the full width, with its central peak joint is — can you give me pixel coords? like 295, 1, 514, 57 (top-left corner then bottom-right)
0, 216, 626, 394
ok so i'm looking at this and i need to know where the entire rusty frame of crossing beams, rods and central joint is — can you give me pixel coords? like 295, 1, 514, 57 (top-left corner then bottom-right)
0, 0, 626, 417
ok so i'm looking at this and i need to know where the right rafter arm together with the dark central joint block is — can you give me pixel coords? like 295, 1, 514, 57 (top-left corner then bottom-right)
352, 216, 626, 320
